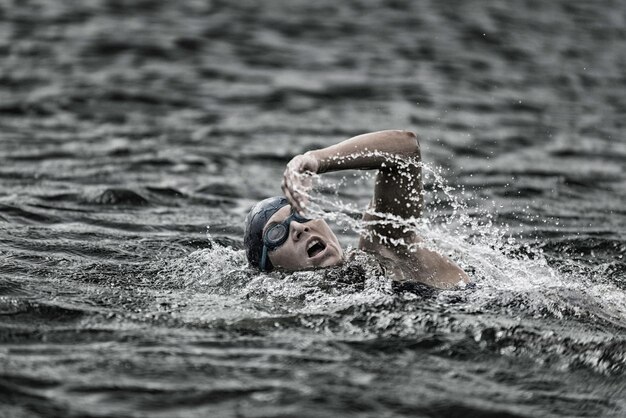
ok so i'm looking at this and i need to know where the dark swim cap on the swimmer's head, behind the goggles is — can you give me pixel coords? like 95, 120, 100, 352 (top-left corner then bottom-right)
243, 196, 289, 271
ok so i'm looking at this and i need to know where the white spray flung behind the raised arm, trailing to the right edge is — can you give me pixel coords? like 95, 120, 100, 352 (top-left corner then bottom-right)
284, 153, 626, 323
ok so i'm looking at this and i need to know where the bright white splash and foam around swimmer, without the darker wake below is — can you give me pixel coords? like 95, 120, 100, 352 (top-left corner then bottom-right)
155, 153, 626, 333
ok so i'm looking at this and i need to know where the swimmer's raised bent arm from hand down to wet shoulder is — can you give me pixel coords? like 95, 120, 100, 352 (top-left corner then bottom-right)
282, 131, 469, 289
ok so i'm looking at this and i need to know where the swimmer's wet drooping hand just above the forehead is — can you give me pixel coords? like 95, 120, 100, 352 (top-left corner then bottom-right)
281, 152, 320, 215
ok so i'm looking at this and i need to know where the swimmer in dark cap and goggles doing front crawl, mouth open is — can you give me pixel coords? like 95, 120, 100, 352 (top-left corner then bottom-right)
244, 130, 469, 289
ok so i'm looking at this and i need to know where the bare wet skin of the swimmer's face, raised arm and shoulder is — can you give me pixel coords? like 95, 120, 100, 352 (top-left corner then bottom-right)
264, 130, 469, 289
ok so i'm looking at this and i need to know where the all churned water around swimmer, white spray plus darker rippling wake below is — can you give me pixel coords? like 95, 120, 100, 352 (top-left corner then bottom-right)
145, 162, 626, 375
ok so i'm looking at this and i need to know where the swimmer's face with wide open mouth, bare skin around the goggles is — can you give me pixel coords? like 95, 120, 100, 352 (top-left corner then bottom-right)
263, 205, 343, 271
